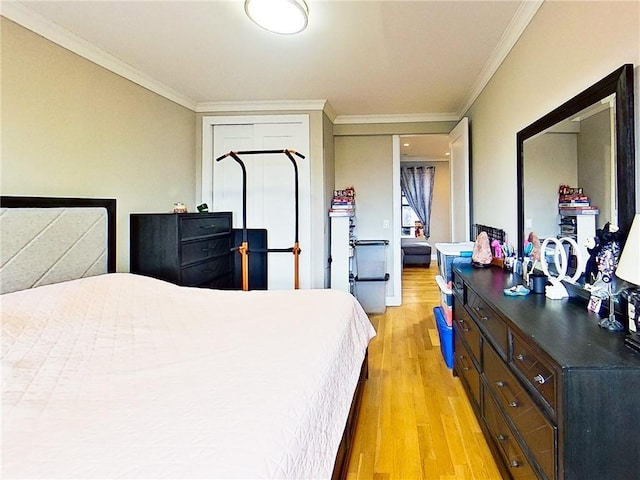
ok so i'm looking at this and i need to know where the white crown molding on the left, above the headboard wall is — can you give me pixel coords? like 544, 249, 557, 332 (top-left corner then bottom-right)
0, 1, 197, 111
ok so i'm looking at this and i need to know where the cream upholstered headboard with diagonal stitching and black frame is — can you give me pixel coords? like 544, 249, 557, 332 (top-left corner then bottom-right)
0, 196, 116, 293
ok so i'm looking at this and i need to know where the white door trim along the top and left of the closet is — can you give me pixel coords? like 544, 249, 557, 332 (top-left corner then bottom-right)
200, 114, 309, 209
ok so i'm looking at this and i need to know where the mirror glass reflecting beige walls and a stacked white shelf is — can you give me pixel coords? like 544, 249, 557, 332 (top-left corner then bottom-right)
523, 94, 618, 270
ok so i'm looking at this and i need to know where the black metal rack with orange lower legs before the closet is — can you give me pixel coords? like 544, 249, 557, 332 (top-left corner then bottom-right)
216, 149, 305, 291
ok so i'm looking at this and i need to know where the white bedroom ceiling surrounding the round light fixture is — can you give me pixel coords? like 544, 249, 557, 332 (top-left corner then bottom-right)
2, 0, 542, 123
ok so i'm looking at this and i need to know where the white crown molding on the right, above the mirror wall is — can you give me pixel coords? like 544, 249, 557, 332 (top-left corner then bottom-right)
458, 0, 544, 118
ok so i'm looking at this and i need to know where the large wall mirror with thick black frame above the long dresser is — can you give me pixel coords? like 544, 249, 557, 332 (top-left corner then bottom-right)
517, 64, 636, 284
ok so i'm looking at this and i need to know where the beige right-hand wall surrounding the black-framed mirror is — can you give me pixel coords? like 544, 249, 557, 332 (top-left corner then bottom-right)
467, 1, 640, 242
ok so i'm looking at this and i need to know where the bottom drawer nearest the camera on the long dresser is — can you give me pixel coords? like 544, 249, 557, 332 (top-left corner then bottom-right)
484, 394, 538, 480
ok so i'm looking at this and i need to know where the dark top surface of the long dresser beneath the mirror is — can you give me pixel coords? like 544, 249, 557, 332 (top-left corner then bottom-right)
454, 265, 640, 369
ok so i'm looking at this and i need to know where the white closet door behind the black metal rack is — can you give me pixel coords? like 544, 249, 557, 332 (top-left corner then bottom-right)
213, 122, 311, 290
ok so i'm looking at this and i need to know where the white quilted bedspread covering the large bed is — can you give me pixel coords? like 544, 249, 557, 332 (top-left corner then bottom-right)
0, 274, 375, 479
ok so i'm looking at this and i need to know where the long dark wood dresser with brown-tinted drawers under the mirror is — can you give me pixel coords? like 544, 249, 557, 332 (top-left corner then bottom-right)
453, 266, 640, 480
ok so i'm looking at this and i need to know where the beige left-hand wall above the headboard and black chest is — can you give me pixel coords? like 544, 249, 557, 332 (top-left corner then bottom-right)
0, 17, 195, 271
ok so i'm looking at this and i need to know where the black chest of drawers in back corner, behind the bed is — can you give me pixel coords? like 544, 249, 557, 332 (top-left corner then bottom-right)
130, 212, 233, 288
